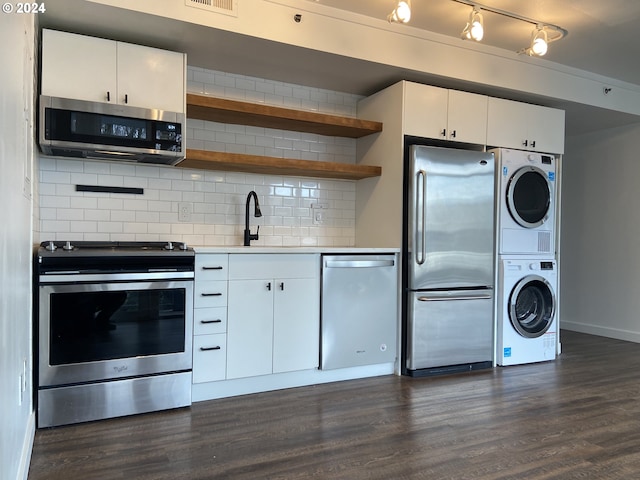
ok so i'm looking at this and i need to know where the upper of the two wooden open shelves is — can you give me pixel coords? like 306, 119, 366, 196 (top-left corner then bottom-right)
187, 93, 382, 138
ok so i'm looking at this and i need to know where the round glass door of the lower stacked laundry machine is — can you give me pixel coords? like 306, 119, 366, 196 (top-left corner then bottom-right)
508, 275, 556, 338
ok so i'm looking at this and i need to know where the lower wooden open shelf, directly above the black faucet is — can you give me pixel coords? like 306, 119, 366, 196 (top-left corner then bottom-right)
176, 149, 382, 180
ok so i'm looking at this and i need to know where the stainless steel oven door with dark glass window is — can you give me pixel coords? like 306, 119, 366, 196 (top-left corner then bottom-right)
38, 280, 193, 387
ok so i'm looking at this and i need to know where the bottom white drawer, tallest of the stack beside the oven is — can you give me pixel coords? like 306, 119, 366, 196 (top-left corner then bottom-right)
193, 333, 227, 383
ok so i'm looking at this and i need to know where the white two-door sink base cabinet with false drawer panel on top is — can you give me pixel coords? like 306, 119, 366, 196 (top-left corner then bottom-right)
227, 254, 320, 379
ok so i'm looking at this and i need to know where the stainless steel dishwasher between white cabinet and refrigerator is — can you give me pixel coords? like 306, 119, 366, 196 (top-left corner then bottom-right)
320, 254, 398, 370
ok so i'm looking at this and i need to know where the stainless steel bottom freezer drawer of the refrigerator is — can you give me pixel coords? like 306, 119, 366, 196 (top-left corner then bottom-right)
406, 289, 493, 370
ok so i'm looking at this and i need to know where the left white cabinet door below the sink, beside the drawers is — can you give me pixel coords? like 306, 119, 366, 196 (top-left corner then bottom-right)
227, 280, 274, 379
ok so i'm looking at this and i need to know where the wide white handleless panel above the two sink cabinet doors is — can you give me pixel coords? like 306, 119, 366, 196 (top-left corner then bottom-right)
229, 253, 320, 280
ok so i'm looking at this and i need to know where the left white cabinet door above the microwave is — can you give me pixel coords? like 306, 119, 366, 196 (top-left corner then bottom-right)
42, 29, 116, 102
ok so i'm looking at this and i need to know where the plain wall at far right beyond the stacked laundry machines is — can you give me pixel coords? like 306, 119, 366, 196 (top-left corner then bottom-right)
560, 124, 640, 342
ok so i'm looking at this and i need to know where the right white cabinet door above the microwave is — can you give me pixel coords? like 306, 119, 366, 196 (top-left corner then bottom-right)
118, 42, 185, 113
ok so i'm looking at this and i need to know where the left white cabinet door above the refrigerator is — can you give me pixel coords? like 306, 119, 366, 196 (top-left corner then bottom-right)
403, 82, 448, 139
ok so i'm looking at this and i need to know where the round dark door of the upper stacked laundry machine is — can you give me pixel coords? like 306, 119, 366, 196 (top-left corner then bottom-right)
506, 166, 551, 228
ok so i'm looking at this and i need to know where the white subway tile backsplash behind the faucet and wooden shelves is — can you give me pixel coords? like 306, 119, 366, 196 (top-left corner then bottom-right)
39, 67, 360, 247
